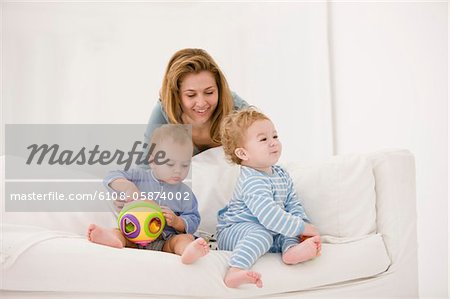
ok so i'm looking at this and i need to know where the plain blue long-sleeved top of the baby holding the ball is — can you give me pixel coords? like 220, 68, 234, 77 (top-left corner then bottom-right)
103, 168, 200, 240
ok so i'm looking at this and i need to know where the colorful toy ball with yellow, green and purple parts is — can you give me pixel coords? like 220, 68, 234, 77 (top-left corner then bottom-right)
117, 201, 166, 246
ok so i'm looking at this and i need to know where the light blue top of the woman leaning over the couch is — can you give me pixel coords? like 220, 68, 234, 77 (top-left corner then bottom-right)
142, 92, 248, 161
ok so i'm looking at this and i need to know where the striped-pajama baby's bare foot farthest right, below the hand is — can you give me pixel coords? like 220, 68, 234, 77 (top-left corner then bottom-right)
282, 236, 321, 265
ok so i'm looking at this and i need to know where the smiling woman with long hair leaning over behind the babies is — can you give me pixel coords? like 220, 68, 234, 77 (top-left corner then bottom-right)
145, 49, 248, 159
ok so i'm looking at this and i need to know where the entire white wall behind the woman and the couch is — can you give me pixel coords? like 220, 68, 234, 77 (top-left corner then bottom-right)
1, 1, 448, 297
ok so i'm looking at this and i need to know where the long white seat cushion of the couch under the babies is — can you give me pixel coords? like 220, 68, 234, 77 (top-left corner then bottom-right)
2, 226, 390, 298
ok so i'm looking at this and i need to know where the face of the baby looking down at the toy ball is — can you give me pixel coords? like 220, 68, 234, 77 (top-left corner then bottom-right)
150, 139, 193, 184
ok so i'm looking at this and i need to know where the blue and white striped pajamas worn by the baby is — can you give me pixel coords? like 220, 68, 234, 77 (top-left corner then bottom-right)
217, 165, 310, 269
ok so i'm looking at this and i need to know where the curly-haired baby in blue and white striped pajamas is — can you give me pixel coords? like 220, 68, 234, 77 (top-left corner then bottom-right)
217, 108, 321, 288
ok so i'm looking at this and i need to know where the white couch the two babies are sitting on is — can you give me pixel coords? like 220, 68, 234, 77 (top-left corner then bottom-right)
0, 148, 418, 298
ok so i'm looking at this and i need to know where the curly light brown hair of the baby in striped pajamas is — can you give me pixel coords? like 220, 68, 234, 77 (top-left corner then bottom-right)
220, 107, 270, 164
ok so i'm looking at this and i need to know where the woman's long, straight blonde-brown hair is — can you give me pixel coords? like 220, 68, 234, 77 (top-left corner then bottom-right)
161, 49, 233, 143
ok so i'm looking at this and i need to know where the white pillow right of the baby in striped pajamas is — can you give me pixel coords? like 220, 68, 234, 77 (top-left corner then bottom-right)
285, 155, 376, 238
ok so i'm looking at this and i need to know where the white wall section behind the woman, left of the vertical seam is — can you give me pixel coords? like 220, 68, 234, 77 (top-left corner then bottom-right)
3, 1, 332, 164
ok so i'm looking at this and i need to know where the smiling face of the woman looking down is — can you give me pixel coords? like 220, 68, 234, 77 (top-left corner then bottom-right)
180, 71, 219, 125
